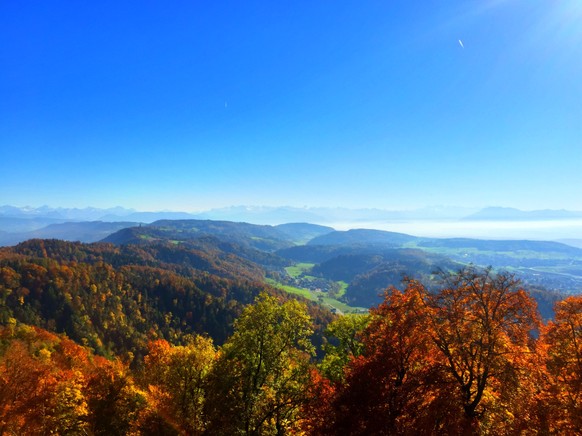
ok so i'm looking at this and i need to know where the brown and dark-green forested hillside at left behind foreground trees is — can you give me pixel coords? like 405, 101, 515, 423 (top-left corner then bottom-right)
0, 240, 331, 361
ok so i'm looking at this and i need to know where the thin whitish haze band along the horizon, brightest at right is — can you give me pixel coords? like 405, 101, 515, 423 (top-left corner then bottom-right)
0, 205, 582, 240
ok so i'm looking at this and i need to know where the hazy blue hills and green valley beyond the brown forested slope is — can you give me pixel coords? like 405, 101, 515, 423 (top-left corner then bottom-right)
0, 211, 582, 316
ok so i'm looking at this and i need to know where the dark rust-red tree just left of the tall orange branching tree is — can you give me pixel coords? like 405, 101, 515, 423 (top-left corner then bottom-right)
304, 287, 440, 435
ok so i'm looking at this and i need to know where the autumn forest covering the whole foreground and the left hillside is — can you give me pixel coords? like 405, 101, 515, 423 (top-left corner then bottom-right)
0, 240, 582, 435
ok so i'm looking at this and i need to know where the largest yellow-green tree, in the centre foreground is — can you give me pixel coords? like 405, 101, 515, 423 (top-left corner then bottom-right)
206, 293, 314, 434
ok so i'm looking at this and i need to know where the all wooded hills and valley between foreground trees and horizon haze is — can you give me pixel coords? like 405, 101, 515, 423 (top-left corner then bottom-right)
0, 220, 582, 354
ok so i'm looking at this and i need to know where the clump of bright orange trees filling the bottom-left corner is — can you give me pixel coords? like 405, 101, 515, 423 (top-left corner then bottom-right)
0, 320, 146, 435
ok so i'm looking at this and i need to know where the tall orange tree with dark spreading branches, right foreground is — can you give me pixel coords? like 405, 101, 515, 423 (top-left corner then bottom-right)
416, 267, 540, 431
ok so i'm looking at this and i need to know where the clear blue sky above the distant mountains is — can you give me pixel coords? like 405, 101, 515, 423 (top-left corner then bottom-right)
0, 0, 582, 211
